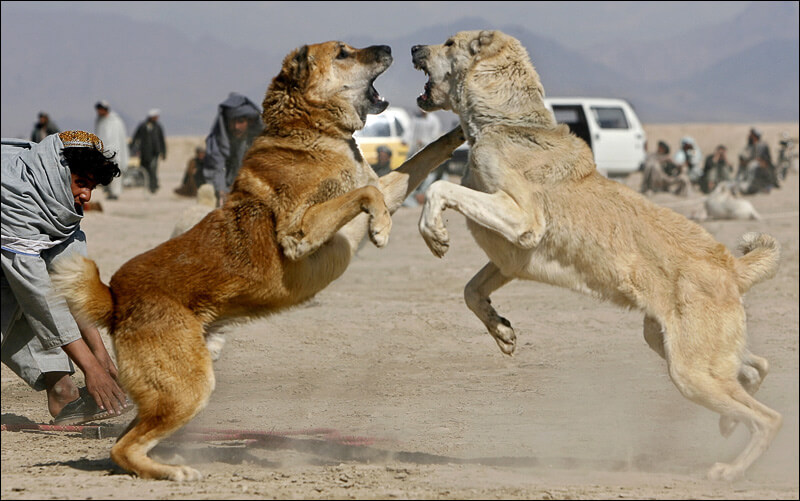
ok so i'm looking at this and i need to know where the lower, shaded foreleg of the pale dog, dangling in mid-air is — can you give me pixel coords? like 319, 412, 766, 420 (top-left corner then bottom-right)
464, 262, 517, 355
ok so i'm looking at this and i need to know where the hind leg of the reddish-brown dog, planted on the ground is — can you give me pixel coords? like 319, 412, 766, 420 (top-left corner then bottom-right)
111, 324, 214, 481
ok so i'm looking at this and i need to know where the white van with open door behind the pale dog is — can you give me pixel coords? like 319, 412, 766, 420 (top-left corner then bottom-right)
544, 97, 647, 176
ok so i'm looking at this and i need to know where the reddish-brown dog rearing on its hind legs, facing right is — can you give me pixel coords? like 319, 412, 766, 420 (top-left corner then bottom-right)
54, 42, 464, 480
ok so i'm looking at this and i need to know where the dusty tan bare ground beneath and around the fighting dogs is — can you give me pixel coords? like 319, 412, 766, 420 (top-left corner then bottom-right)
2, 124, 798, 499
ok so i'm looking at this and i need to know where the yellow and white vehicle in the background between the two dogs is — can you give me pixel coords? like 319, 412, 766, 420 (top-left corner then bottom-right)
353, 106, 411, 169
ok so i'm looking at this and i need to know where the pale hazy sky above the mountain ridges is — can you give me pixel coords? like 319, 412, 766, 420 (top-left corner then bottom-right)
18, 1, 749, 49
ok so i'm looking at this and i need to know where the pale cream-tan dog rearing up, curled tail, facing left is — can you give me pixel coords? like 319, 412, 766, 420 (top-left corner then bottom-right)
412, 31, 781, 479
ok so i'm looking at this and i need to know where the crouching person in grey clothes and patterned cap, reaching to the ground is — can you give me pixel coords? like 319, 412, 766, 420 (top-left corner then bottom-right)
0, 131, 130, 425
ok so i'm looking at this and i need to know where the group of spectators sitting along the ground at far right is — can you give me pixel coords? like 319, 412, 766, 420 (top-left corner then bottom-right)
640, 128, 798, 196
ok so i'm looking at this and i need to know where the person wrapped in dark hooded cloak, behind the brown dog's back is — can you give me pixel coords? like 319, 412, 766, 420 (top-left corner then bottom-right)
203, 92, 264, 205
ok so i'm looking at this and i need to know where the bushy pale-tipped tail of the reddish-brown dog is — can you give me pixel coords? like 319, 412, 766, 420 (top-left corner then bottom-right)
50, 253, 114, 328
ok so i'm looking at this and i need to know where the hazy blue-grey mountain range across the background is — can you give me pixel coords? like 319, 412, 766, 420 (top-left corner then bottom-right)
0, 1, 800, 137
